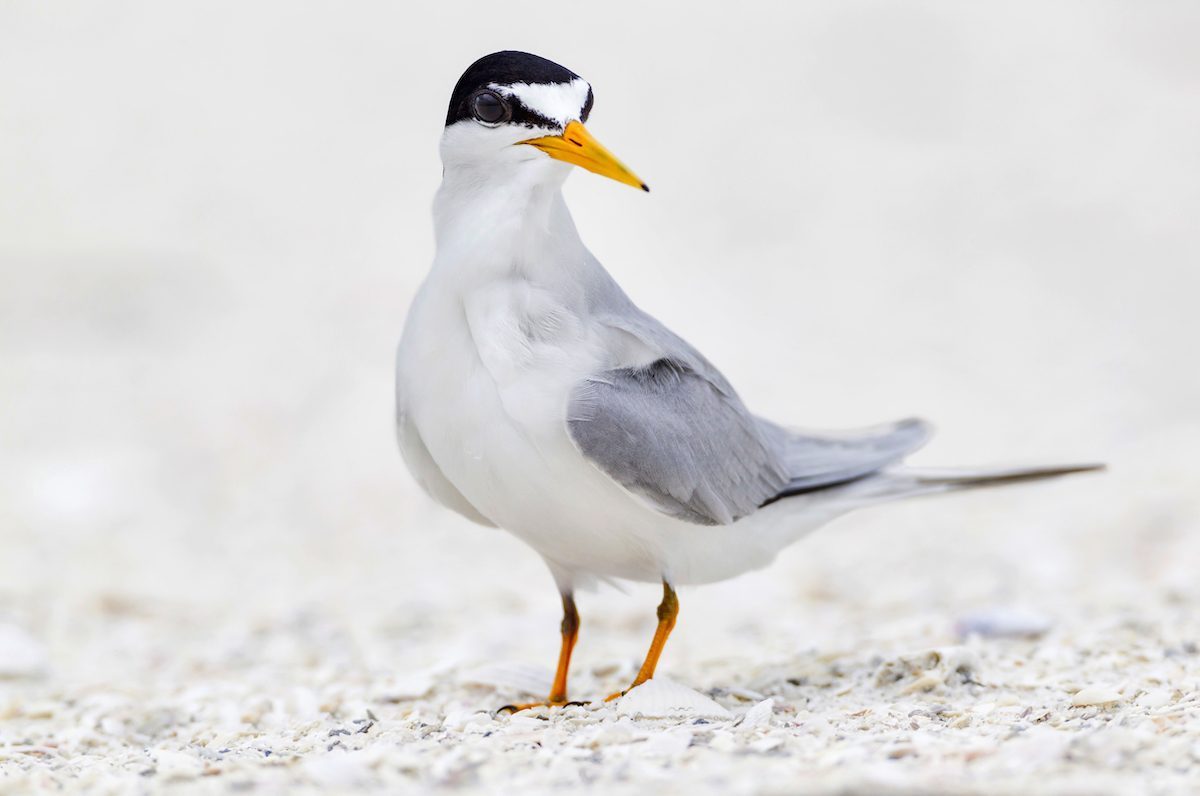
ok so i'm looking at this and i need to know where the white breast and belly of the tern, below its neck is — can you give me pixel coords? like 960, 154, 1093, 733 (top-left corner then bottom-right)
397, 282, 820, 583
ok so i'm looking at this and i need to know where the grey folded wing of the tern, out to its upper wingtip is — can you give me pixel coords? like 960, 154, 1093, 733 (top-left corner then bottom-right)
568, 304, 930, 525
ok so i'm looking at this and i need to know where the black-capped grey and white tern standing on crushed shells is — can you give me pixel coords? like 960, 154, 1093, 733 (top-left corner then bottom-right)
396, 50, 1103, 711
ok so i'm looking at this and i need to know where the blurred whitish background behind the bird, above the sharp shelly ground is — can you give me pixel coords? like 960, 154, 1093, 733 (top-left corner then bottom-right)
0, 0, 1200, 705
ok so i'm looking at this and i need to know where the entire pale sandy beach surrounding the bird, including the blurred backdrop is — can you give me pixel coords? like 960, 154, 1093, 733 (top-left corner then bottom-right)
0, 2, 1200, 795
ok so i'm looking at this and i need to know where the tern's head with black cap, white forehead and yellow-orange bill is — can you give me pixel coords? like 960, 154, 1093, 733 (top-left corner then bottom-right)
442, 50, 649, 191
